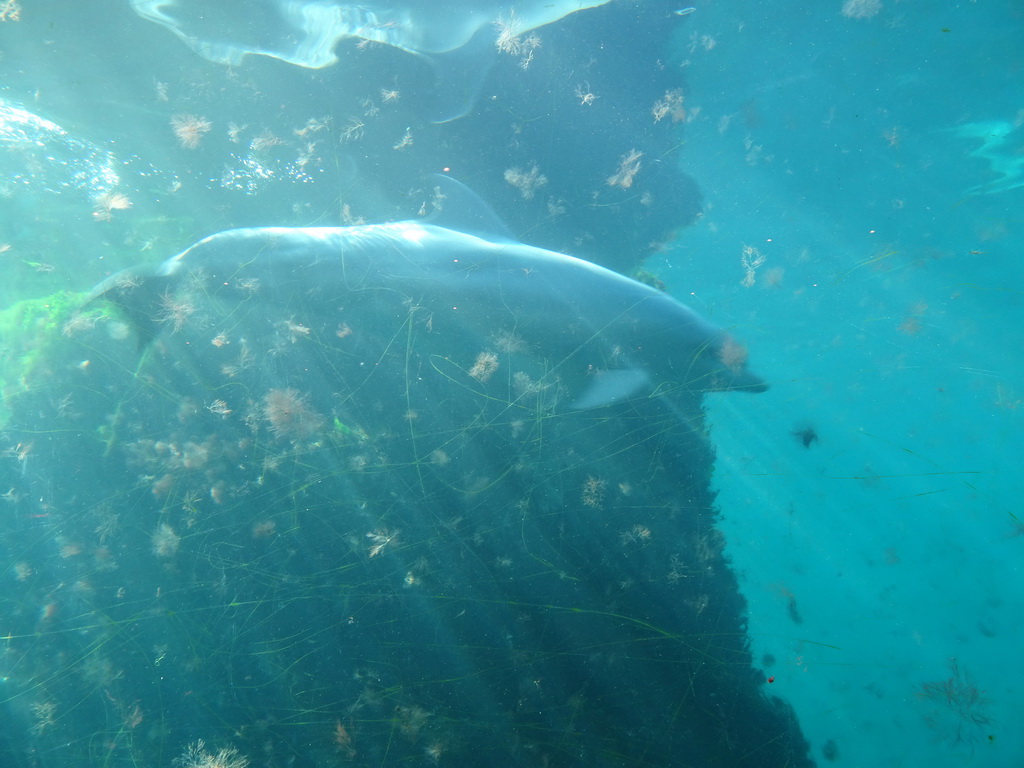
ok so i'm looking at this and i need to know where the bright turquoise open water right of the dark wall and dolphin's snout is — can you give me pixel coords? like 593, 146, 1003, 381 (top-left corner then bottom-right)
667, 3, 1024, 766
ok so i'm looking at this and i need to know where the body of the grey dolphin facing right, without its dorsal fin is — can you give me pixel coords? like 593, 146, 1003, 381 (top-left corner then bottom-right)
90, 210, 767, 410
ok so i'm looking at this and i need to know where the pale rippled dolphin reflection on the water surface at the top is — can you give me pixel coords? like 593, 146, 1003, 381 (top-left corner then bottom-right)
131, 0, 608, 123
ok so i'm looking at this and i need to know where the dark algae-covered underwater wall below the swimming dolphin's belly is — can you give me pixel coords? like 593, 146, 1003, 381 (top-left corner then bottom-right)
0, 275, 812, 768
